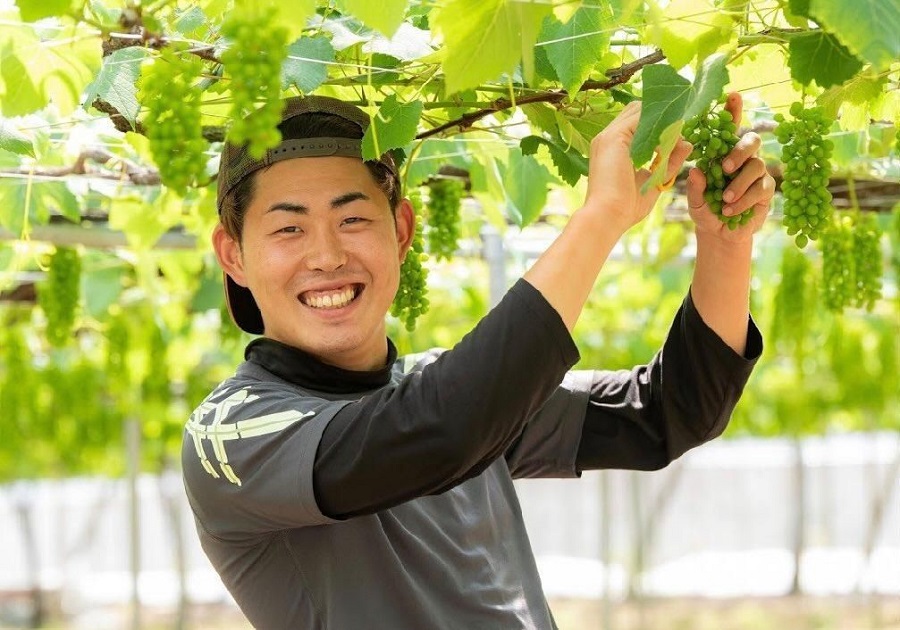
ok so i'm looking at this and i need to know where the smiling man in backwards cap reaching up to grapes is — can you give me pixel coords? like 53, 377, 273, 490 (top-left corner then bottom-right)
183, 95, 773, 630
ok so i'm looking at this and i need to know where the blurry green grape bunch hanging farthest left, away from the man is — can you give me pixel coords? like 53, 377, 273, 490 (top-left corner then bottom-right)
38, 247, 81, 348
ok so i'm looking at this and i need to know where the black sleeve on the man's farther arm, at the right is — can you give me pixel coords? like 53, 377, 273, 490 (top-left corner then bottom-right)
576, 293, 763, 471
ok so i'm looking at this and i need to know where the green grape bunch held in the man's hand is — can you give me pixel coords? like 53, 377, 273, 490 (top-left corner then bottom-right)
682, 100, 753, 230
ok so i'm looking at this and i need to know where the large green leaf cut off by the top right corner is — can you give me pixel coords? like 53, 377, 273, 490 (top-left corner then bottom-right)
809, 0, 900, 70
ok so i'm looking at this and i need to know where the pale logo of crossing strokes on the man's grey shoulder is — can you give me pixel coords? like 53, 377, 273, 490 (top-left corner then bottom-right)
185, 389, 315, 486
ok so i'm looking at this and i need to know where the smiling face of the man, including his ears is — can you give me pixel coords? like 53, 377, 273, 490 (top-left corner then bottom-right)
213, 157, 414, 370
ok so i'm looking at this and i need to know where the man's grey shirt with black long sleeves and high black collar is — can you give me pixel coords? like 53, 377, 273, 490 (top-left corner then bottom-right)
183, 281, 761, 630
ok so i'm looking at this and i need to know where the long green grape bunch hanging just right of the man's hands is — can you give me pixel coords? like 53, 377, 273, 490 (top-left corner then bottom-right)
775, 102, 834, 249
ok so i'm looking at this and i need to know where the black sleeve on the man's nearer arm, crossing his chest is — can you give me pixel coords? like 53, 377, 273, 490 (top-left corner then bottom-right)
313, 280, 583, 518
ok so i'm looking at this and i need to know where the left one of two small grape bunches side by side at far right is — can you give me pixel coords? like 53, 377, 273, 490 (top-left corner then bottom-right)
819, 216, 856, 313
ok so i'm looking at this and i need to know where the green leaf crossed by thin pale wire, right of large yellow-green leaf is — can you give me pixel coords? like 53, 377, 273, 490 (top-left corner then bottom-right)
541, 7, 609, 94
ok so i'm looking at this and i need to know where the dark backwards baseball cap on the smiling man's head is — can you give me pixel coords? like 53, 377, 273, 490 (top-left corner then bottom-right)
216, 96, 400, 335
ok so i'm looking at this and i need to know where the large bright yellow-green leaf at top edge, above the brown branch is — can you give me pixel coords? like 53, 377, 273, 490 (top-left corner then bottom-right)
433, 0, 551, 94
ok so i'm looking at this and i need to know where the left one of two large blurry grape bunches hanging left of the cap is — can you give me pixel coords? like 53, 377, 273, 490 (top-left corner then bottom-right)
140, 49, 207, 196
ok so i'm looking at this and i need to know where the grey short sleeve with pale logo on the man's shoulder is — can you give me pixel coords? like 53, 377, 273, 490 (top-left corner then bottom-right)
182, 380, 346, 538
